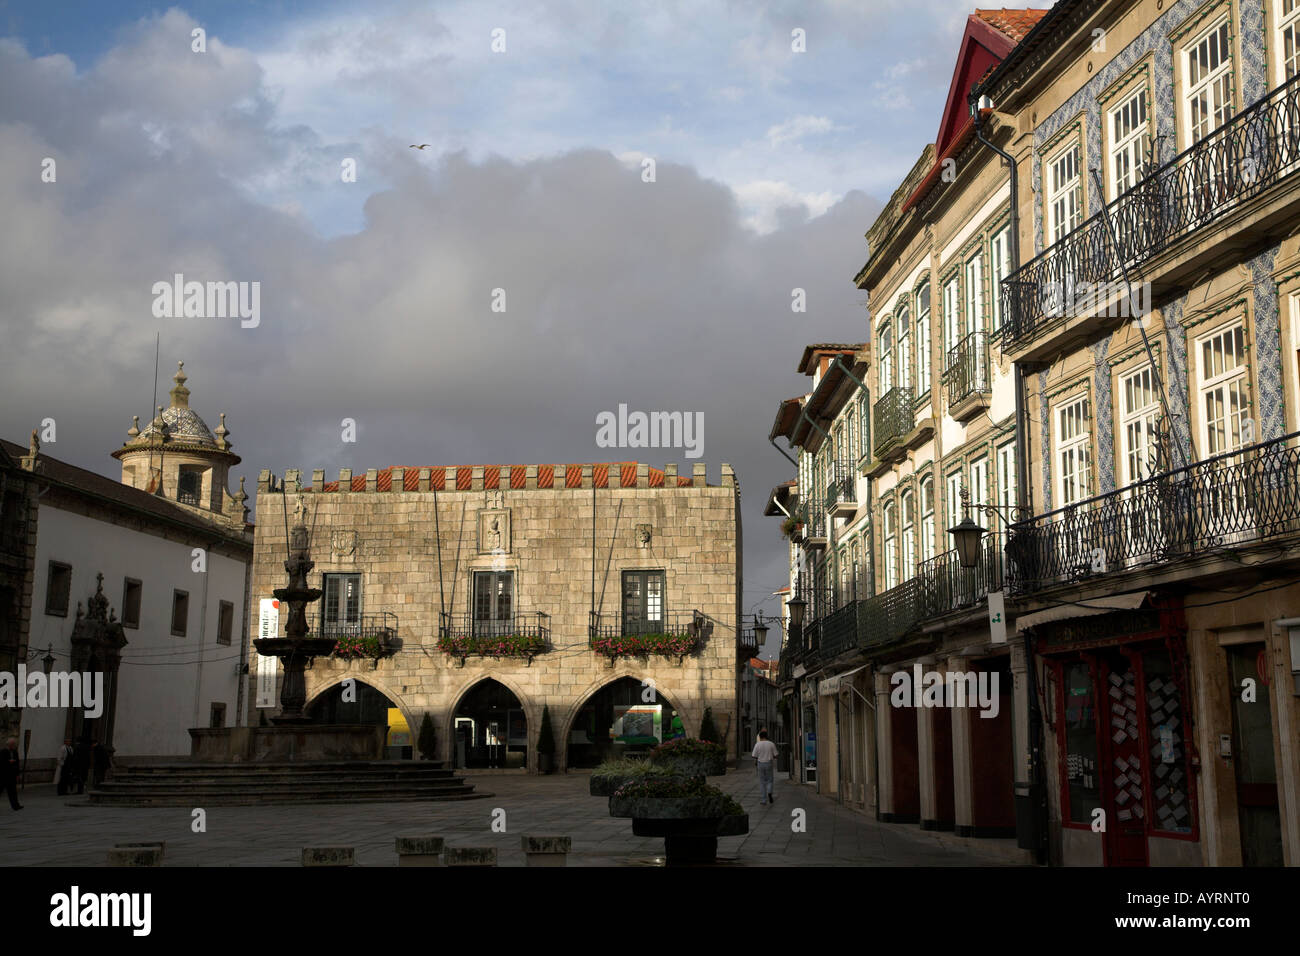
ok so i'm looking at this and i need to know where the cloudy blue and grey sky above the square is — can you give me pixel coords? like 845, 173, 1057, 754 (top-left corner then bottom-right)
0, 0, 1003, 650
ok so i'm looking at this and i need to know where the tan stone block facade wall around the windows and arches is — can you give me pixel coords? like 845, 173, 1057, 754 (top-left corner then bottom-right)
246, 464, 742, 767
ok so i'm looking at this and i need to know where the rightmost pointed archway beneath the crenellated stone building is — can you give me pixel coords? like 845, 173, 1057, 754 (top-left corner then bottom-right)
556, 672, 689, 770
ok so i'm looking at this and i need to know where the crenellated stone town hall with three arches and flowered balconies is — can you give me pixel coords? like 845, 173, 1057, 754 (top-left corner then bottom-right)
248, 463, 753, 770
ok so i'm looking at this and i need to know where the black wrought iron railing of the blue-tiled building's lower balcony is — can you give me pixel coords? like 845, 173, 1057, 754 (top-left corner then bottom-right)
1006, 432, 1300, 593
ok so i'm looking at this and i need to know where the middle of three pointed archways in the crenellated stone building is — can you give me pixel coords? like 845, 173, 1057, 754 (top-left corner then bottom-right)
447, 674, 533, 770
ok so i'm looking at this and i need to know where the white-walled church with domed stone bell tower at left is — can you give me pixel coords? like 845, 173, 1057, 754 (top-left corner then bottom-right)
0, 363, 252, 782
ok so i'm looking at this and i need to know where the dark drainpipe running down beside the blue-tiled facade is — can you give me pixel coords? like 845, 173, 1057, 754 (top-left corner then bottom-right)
970, 100, 1048, 862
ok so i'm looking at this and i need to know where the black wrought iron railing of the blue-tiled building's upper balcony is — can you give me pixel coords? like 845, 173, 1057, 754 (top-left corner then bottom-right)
1000, 75, 1300, 349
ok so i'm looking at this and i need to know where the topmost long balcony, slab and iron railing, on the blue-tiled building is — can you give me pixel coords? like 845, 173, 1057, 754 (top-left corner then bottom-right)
998, 75, 1300, 360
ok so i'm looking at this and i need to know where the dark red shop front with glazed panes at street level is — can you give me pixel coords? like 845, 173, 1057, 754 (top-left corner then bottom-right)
1035, 605, 1200, 866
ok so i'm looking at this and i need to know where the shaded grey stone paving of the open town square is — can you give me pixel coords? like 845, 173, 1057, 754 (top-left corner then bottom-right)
0, 769, 1024, 866
